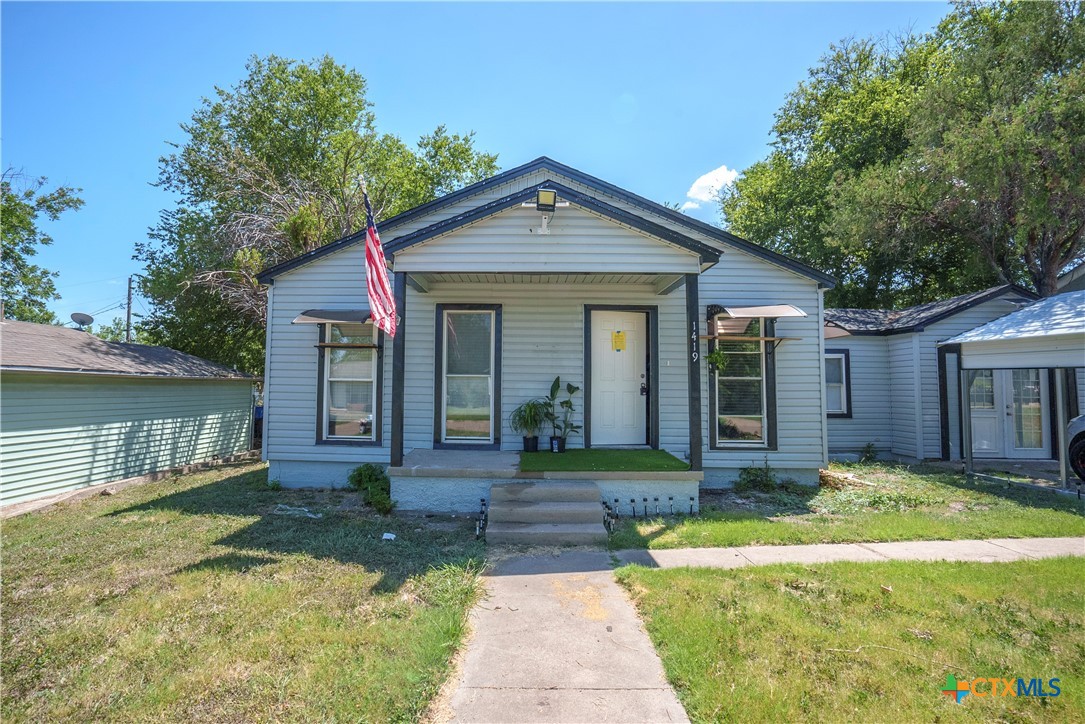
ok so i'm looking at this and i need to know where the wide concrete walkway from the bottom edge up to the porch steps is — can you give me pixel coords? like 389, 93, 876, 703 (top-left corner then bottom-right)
449, 549, 688, 722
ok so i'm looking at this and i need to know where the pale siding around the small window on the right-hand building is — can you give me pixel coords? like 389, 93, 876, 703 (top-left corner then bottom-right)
825, 336, 893, 453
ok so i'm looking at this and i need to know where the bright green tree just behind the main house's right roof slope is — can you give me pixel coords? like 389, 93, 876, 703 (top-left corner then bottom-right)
720, 37, 993, 307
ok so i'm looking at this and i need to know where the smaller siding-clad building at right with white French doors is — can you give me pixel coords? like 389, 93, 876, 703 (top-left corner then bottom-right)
825, 284, 1085, 460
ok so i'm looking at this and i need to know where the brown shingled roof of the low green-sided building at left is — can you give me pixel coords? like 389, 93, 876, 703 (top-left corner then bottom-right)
0, 319, 255, 380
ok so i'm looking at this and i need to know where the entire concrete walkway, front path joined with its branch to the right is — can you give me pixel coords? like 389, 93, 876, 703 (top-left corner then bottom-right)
448, 537, 1085, 723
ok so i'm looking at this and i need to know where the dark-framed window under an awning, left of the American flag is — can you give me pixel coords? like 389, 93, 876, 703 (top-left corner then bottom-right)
320, 325, 379, 442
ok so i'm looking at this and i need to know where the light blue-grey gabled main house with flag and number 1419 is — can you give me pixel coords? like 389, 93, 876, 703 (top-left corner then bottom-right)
260, 157, 833, 509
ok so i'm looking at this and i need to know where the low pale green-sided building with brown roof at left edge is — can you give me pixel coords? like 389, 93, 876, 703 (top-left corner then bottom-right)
0, 320, 255, 505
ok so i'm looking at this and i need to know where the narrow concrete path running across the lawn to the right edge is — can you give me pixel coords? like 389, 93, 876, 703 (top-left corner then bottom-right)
615, 537, 1085, 568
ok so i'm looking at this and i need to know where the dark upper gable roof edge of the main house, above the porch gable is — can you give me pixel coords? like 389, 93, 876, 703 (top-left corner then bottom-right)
257, 156, 837, 289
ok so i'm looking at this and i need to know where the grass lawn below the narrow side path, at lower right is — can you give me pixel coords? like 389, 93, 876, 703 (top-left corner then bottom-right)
617, 558, 1085, 722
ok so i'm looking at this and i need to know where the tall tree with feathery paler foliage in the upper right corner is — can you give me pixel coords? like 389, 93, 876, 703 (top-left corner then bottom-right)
872, 2, 1085, 296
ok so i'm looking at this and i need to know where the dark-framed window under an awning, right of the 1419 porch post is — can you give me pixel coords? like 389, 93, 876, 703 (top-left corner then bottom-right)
709, 316, 776, 448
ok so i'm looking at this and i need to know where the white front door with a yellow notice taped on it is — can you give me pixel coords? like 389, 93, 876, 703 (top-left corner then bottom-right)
591, 310, 648, 446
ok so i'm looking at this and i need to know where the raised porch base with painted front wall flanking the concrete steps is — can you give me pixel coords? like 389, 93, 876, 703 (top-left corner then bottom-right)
388, 449, 704, 516
